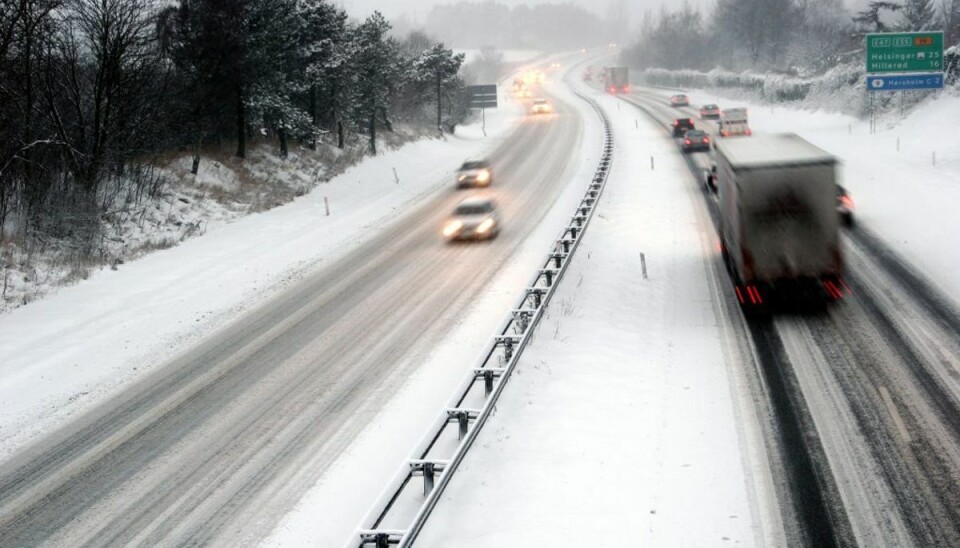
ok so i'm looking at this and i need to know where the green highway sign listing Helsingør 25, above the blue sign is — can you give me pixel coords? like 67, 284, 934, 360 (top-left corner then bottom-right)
867, 31, 943, 73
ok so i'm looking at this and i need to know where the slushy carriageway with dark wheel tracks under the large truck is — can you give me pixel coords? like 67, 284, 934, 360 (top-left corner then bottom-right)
626, 90, 960, 546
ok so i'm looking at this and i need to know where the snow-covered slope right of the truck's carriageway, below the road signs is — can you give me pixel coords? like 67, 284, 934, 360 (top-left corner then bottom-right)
690, 87, 960, 306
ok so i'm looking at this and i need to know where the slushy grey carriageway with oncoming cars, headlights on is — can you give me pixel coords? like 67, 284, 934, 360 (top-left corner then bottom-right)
0, 84, 583, 546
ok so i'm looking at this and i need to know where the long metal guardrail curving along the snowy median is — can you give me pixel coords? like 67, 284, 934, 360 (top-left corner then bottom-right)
347, 88, 613, 548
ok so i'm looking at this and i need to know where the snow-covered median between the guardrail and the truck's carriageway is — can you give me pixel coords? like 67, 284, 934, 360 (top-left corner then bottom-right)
418, 75, 782, 547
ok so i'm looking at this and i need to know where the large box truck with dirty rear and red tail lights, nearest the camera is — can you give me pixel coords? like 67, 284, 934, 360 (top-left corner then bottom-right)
716, 134, 845, 311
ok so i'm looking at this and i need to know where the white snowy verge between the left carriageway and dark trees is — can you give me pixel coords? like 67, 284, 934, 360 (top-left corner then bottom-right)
0, 86, 523, 460
